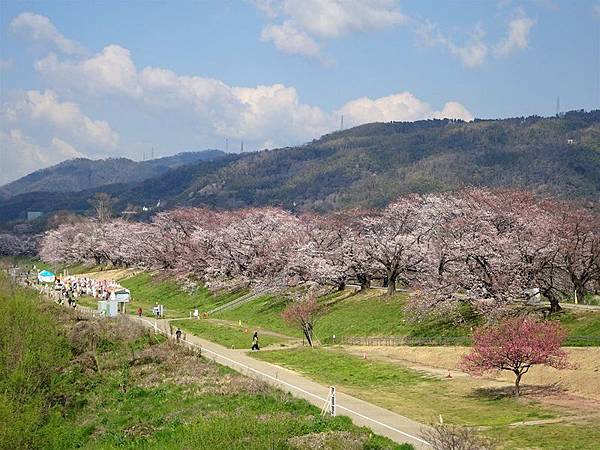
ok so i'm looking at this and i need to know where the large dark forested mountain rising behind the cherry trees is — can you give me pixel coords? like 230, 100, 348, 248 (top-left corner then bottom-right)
0, 111, 600, 227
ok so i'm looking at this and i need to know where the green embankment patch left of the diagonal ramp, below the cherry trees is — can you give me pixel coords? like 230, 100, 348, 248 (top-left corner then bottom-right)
120, 272, 245, 318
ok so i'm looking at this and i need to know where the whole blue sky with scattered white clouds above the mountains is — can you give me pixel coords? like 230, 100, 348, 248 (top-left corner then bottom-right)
0, 0, 600, 184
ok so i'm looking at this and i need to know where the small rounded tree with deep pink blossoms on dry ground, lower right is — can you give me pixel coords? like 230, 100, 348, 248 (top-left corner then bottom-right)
461, 317, 569, 397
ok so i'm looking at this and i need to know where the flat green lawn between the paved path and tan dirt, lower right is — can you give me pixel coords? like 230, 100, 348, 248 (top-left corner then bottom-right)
253, 348, 600, 449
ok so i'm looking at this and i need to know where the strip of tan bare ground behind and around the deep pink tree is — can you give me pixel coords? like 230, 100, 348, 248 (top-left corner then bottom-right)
344, 346, 600, 402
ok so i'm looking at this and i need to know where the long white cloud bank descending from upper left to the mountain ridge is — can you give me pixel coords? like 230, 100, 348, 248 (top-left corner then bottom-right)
37, 46, 472, 146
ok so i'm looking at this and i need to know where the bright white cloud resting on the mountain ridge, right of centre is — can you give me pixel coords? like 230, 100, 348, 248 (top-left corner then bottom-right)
339, 92, 473, 126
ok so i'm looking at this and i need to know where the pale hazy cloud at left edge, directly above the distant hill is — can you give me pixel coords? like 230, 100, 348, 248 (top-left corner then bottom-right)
0, 128, 84, 185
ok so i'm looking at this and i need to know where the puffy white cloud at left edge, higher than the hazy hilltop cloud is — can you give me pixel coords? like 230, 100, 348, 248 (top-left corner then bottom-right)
2, 90, 119, 151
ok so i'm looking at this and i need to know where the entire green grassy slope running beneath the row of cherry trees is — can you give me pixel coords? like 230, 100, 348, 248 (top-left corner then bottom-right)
18, 260, 600, 346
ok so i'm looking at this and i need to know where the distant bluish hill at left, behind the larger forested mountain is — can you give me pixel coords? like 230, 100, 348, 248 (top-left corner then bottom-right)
0, 150, 224, 198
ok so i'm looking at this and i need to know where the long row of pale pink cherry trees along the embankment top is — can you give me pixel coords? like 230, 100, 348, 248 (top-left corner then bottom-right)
41, 189, 600, 311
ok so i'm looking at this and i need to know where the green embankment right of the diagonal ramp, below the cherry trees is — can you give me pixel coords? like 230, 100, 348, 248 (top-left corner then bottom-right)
215, 290, 600, 346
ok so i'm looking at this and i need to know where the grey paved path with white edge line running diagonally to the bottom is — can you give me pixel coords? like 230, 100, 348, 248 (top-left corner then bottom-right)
138, 317, 431, 449
